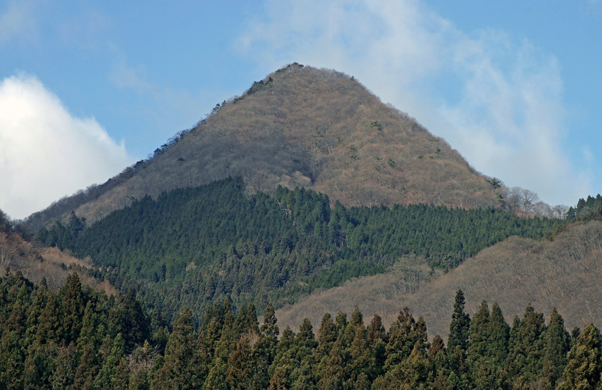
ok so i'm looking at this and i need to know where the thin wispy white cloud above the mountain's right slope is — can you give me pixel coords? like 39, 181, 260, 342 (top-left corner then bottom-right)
238, 0, 591, 204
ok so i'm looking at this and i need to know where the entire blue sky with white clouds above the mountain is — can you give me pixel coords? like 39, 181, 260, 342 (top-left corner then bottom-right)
0, 0, 602, 218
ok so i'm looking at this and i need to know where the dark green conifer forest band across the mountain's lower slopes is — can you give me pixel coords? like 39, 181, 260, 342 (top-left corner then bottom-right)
37, 178, 561, 322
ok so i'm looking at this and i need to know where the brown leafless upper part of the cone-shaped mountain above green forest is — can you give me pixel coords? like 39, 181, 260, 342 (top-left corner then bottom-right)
28, 64, 498, 231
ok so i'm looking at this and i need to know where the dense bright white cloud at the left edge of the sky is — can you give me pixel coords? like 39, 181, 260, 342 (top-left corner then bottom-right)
0, 74, 132, 218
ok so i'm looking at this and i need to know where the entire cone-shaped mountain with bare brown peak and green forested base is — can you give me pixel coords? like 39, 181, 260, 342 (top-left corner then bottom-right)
16, 64, 561, 324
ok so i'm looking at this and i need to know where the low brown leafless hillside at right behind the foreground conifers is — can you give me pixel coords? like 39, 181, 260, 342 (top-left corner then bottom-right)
277, 221, 602, 337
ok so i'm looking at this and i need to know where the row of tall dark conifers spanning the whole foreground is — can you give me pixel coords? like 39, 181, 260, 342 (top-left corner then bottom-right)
0, 273, 602, 390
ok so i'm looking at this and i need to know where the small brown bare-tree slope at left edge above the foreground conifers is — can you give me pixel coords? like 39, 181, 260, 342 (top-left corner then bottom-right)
0, 232, 116, 295
